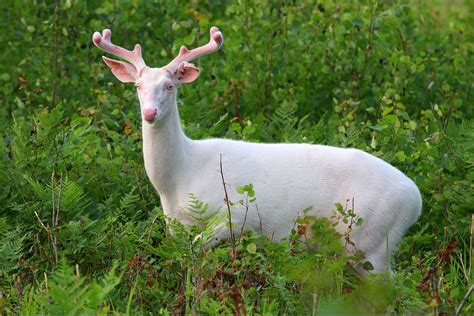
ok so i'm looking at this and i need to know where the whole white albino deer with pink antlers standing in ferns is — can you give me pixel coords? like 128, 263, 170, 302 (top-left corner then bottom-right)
92, 27, 421, 272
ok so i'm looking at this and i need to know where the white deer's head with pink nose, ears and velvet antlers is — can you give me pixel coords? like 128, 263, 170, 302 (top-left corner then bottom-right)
92, 27, 224, 124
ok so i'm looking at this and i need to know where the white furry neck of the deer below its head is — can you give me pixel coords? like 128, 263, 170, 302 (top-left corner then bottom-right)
142, 94, 189, 195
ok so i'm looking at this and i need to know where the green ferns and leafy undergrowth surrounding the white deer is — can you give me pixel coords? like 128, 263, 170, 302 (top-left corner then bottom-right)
0, 0, 474, 314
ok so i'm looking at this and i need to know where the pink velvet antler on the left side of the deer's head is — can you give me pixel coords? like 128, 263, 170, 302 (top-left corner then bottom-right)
92, 29, 146, 72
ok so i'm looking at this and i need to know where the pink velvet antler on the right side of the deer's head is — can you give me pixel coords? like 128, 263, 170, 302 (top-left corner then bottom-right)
165, 26, 224, 72
